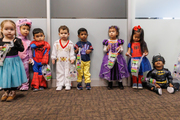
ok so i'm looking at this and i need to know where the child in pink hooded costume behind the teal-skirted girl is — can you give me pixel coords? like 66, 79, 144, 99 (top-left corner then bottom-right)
16, 19, 32, 91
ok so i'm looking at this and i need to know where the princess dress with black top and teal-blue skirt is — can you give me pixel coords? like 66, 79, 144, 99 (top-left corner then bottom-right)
0, 38, 27, 89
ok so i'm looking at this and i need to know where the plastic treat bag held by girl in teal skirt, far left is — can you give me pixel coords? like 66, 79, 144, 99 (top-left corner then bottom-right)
0, 41, 14, 66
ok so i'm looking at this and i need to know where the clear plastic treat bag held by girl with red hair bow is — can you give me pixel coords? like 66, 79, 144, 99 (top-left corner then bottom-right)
131, 54, 144, 77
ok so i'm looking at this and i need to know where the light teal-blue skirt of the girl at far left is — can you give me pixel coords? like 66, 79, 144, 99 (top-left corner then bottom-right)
0, 55, 27, 88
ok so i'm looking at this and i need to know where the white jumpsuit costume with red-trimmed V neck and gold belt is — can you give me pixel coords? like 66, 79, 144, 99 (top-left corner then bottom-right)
51, 40, 75, 87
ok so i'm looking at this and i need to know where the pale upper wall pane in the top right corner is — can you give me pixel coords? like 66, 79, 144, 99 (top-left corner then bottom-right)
135, 0, 180, 18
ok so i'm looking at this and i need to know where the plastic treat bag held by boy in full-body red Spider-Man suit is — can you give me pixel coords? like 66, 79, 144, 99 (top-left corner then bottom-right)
42, 65, 51, 81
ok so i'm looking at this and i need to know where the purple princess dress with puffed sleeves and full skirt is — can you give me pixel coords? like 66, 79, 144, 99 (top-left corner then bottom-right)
99, 39, 129, 81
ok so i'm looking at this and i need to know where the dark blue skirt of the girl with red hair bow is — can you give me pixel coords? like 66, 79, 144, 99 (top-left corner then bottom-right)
128, 57, 151, 75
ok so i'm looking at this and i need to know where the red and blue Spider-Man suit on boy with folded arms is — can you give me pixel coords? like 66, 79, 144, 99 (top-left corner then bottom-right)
30, 41, 50, 89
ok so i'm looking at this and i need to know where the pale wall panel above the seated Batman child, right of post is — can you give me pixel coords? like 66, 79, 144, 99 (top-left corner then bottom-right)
133, 19, 180, 72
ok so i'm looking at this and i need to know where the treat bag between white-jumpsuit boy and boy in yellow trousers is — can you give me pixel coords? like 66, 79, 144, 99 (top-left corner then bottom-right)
67, 65, 78, 81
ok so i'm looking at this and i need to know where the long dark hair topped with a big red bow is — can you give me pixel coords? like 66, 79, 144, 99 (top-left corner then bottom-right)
130, 25, 148, 52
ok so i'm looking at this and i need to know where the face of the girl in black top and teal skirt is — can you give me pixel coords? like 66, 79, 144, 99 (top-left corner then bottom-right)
1, 22, 16, 39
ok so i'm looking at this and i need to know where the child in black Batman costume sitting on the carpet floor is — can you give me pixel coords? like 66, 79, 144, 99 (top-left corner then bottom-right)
147, 55, 179, 95
